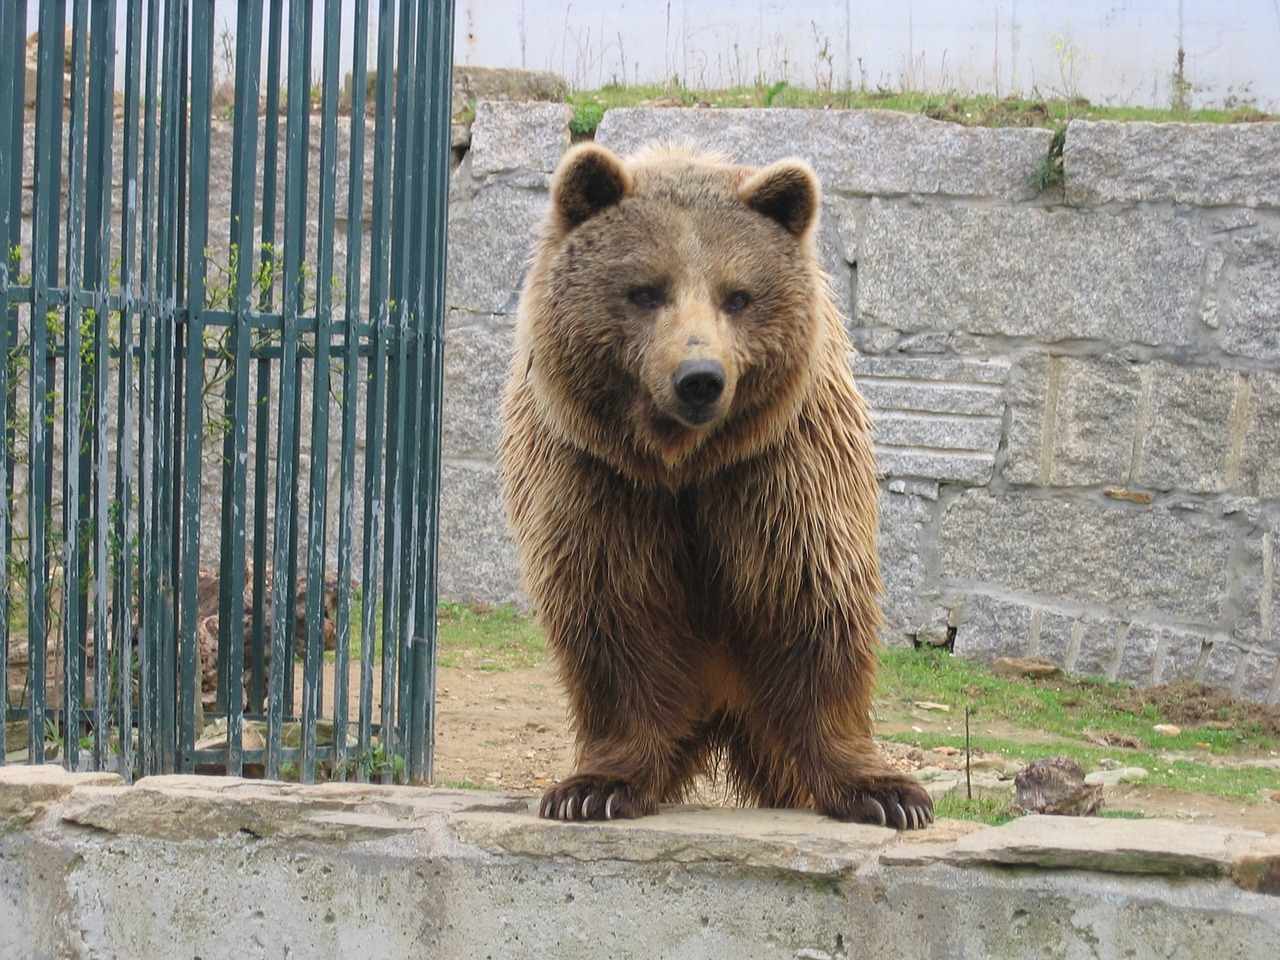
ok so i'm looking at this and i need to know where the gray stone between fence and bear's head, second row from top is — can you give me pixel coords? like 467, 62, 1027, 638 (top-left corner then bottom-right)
447, 183, 548, 314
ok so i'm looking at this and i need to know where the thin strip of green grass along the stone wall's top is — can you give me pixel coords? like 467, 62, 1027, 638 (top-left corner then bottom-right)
567, 83, 1275, 136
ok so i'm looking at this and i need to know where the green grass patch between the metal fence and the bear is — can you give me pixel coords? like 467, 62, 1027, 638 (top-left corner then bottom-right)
436, 603, 547, 672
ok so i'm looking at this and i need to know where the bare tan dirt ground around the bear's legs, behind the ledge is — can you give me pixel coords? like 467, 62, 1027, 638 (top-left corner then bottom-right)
435, 667, 1280, 833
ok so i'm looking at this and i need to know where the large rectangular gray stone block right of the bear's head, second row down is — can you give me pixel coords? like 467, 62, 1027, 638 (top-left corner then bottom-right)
854, 201, 1204, 344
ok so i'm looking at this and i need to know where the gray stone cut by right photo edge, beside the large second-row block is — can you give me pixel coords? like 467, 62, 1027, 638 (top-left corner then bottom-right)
1217, 230, 1280, 364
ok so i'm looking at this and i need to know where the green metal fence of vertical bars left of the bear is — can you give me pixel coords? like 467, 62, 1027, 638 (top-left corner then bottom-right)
0, 0, 453, 781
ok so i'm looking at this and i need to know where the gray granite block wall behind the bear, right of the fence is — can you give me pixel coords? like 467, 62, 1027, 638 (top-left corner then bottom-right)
440, 104, 1280, 703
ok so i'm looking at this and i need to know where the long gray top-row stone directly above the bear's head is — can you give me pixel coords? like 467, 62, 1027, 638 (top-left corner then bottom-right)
595, 108, 1052, 200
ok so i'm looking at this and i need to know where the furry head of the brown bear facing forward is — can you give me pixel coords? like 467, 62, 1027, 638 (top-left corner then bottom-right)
516, 145, 833, 486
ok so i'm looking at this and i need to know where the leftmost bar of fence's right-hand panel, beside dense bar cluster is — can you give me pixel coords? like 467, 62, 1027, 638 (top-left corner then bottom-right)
178, 3, 214, 773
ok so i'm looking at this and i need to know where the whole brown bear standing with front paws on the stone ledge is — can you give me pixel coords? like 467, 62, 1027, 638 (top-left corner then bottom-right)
500, 143, 933, 829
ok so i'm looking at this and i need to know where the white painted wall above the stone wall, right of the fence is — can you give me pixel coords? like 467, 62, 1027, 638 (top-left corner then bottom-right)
454, 0, 1280, 110
